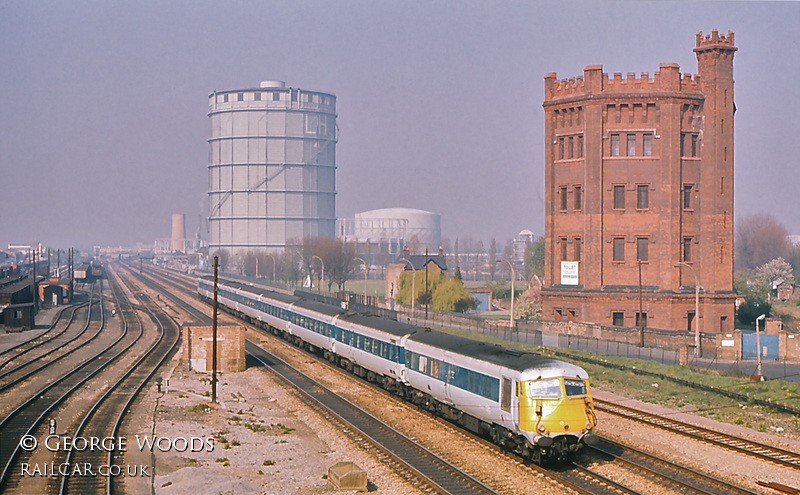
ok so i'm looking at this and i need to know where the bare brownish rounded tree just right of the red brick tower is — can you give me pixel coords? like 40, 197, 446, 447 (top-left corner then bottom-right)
734, 213, 791, 270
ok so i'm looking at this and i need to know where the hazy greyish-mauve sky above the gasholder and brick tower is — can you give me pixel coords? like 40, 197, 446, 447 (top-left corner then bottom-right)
0, 0, 800, 252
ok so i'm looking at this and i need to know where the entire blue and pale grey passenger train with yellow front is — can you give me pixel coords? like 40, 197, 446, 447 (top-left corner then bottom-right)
198, 277, 597, 463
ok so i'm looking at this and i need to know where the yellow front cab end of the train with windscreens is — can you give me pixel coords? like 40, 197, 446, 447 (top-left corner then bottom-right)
517, 377, 597, 460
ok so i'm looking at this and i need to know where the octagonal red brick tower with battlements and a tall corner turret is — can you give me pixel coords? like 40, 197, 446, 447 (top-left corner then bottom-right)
542, 30, 736, 332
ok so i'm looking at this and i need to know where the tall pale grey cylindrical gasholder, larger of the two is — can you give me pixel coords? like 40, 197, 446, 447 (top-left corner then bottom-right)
208, 81, 337, 255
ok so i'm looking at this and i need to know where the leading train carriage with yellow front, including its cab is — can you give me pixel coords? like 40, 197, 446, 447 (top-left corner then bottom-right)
406, 332, 596, 461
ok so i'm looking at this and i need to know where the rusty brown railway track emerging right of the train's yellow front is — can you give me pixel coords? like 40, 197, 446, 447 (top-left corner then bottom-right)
594, 399, 800, 469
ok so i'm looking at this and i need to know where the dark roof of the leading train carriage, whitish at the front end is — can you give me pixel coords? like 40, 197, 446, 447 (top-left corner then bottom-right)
409, 331, 588, 380
